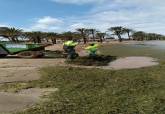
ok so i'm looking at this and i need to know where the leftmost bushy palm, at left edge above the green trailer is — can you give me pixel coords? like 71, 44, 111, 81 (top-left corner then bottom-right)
0, 27, 22, 42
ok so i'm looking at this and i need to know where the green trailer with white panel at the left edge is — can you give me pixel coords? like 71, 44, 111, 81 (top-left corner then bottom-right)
0, 42, 48, 58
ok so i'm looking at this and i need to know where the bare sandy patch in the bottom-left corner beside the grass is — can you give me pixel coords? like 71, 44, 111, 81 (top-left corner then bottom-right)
0, 88, 58, 114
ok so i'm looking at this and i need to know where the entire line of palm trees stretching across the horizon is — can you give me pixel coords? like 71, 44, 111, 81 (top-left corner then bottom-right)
0, 26, 165, 44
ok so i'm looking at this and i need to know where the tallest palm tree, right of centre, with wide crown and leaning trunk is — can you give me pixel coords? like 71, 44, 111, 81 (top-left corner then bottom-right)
108, 26, 123, 42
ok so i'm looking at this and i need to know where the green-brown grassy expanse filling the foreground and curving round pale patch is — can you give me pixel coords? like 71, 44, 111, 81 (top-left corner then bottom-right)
10, 45, 165, 114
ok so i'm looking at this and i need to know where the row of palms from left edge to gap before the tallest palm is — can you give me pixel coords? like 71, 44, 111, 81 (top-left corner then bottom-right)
0, 27, 106, 44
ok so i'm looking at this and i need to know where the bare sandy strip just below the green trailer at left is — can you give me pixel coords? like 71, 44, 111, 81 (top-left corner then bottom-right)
0, 59, 64, 83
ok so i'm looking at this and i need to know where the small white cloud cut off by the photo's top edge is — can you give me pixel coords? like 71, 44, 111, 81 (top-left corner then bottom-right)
51, 0, 106, 4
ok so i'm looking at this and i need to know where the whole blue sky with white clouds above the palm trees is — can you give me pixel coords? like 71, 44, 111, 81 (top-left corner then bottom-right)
0, 0, 165, 34
